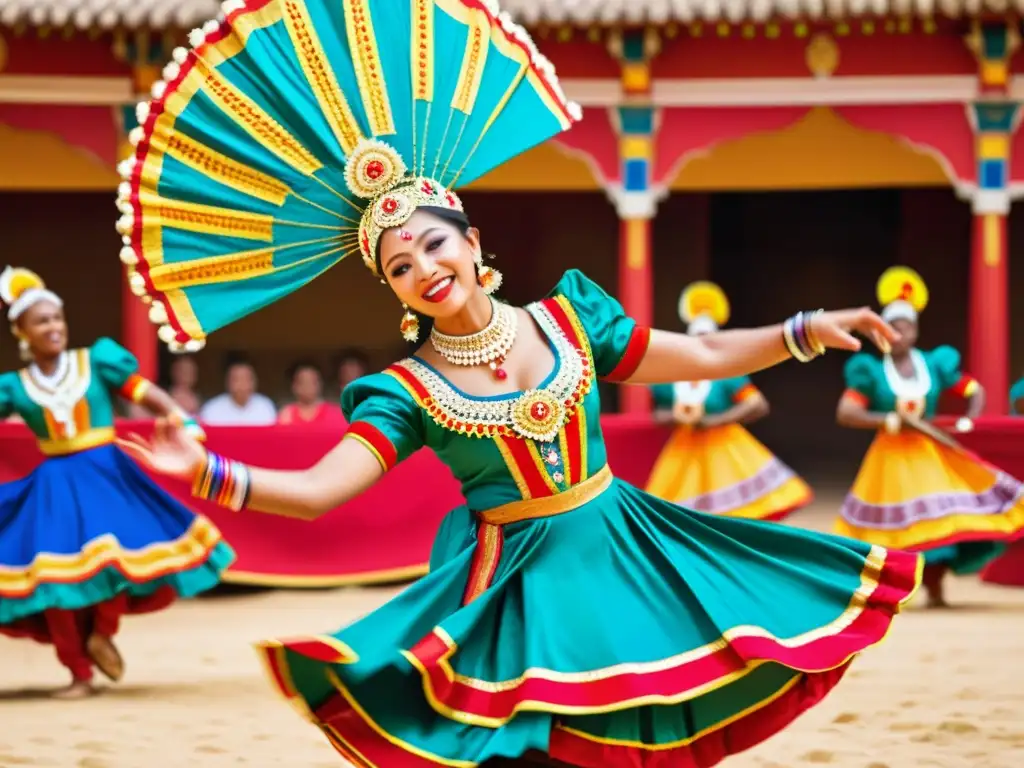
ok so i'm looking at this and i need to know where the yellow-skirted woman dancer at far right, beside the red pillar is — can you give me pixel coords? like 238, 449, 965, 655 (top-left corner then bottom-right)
836, 266, 1024, 607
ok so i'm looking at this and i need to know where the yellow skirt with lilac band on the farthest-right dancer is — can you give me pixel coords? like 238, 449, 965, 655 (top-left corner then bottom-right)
836, 431, 1024, 573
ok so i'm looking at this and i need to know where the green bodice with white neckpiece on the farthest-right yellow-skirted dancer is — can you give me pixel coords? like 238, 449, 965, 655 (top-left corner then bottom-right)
844, 346, 977, 418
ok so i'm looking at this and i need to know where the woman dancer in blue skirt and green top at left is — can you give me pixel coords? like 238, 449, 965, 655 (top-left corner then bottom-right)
0, 267, 233, 698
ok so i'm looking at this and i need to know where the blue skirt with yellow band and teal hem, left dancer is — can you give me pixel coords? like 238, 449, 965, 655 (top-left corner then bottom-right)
0, 445, 234, 642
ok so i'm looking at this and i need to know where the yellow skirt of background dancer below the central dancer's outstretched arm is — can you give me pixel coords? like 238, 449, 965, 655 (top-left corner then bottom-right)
647, 424, 814, 520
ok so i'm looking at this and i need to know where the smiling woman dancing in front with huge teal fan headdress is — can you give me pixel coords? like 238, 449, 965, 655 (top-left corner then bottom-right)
121, 0, 920, 768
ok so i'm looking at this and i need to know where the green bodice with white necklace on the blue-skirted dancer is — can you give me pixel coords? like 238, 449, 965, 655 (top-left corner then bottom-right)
0, 339, 144, 453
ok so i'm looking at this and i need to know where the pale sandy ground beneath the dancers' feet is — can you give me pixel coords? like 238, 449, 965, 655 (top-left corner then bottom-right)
0, 504, 1024, 768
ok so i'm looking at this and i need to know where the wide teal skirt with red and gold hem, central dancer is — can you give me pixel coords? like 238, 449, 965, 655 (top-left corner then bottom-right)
259, 481, 923, 768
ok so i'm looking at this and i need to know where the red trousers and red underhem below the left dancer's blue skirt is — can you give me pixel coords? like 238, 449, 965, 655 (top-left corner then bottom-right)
0, 587, 175, 682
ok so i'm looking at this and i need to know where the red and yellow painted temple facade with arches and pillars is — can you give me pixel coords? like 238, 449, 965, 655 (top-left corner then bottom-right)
0, 0, 1024, 414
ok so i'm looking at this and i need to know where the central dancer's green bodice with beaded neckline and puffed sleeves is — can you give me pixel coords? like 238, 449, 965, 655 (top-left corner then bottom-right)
342, 270, 649, 510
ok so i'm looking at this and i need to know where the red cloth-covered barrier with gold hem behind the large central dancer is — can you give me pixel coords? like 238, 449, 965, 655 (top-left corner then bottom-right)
0, 416, 668, 587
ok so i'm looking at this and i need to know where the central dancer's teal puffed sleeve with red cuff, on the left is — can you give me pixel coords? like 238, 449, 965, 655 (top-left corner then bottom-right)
341, 373, 426, 472
